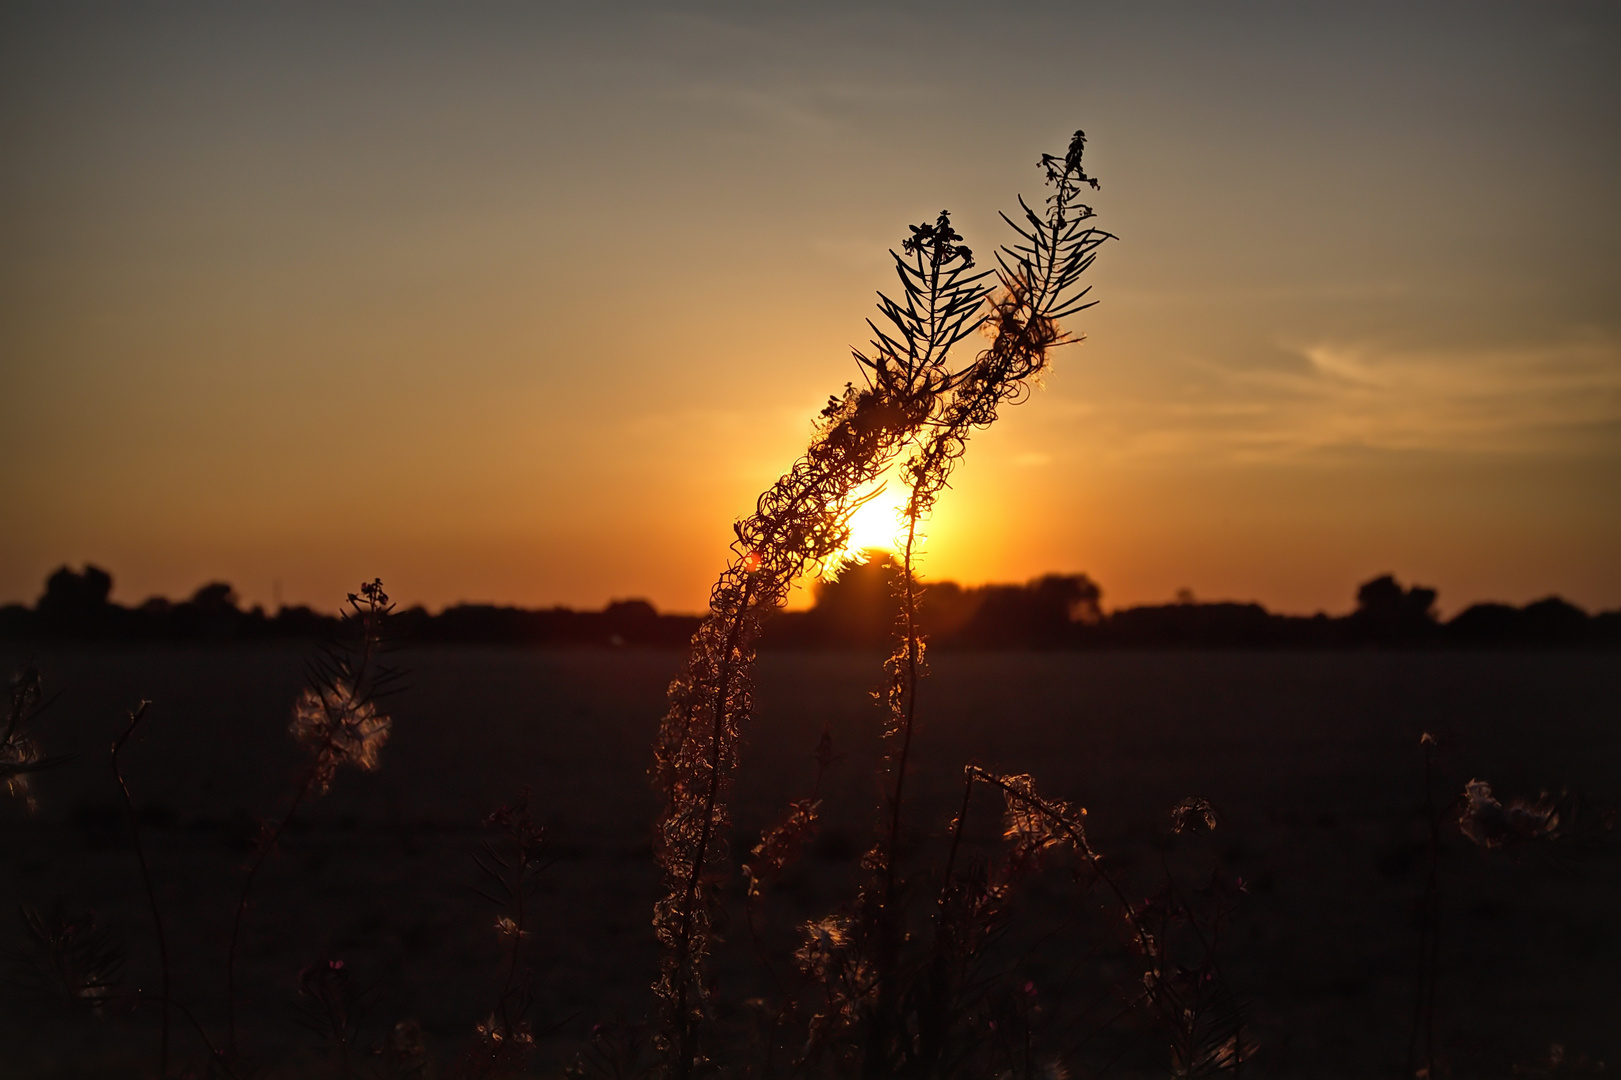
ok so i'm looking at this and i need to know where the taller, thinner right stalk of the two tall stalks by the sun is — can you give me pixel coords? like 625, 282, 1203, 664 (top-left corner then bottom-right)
858, 131, 1110, 1077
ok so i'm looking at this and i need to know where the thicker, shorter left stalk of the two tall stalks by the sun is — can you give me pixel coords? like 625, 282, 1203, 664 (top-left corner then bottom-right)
652, 212, 987, 1080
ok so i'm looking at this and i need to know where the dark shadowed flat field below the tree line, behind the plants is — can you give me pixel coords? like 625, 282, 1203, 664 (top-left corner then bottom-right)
0, 647, 1621, 1077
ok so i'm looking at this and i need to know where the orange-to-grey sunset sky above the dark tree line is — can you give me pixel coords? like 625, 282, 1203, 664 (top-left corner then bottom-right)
0, 2, 1621, 611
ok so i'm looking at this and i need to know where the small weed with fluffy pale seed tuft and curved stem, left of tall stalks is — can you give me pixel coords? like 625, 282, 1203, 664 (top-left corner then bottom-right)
225, 579, 405, 1057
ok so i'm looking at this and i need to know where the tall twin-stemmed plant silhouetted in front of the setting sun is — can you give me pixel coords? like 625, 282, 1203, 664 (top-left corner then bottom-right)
653, 131, 1109, 1080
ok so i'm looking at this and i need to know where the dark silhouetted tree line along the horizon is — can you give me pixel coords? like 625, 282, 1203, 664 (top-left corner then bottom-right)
0, 564, 1621, 649
